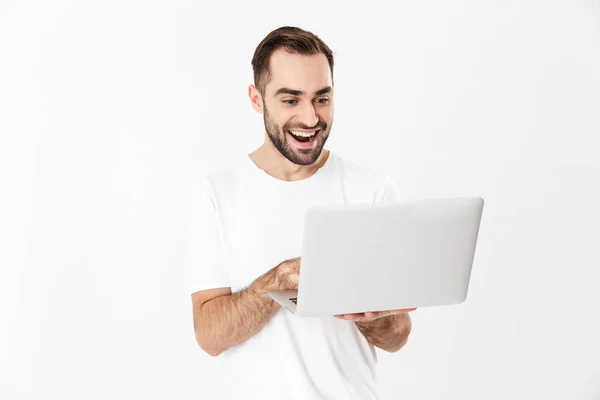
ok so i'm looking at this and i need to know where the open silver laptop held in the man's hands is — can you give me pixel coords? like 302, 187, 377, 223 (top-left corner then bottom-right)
269, 197, 483, 317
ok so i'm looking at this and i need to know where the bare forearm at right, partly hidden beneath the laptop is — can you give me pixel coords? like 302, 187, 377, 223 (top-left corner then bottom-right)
355, 313, 412, 352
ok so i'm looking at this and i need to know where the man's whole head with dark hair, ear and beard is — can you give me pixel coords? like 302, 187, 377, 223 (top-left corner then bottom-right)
249, 26, 333, 165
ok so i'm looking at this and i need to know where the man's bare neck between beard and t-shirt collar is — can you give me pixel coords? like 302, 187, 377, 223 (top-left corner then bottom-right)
249, 143, 329, 181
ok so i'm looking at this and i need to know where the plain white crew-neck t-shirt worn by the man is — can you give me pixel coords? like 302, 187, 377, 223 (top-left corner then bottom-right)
190, 152, 400, 400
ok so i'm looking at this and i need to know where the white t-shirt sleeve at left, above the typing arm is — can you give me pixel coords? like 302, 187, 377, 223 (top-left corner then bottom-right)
189, 177, 231, 293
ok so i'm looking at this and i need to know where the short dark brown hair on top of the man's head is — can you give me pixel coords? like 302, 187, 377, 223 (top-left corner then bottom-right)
252, 26, 333, 96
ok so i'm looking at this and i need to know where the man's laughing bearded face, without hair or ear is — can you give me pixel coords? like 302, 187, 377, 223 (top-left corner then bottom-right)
263, 49, 333, 165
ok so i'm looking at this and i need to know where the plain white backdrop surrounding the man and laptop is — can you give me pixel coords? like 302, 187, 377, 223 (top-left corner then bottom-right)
0, 0, 600, 400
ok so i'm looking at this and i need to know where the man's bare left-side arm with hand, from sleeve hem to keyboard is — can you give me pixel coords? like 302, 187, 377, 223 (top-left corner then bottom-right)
192, 259, 300, 357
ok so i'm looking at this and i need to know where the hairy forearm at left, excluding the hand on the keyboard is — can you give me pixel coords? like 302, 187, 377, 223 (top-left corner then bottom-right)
198, 281, 280, 356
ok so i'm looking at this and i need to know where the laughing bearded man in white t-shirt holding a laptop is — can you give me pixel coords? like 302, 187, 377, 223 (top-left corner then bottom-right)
191, 27, 414, 400
